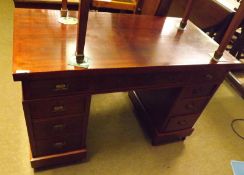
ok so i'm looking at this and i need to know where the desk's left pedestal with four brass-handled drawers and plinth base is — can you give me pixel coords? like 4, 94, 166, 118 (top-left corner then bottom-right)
22, 78, 91, 168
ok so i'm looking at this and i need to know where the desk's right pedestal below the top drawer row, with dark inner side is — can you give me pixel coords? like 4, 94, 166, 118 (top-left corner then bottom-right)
129, 84, 217, 145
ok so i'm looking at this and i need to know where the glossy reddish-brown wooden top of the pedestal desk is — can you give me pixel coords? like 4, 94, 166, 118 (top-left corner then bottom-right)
13, 9, 240, 80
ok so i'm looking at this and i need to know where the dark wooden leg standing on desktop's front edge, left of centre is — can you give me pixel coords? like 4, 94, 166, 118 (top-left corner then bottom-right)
76, 0, 90, 64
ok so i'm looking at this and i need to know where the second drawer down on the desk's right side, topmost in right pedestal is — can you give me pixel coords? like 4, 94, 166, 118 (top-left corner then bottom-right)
181, 85, 217, 98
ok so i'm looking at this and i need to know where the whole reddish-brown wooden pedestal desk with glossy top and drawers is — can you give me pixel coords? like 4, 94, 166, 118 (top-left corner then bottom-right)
13, 9, 243, 168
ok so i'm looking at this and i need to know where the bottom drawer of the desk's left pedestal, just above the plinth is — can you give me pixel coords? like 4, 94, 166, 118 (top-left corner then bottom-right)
34, 135, 84, 157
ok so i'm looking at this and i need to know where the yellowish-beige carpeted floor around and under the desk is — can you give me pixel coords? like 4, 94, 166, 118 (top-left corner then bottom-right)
0, 0, 244, 175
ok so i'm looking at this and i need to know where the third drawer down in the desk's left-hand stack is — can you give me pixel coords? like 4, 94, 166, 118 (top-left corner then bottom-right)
33, 116, 84, 140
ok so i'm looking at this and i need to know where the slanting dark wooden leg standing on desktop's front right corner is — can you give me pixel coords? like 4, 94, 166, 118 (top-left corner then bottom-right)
213, 2, 244, 61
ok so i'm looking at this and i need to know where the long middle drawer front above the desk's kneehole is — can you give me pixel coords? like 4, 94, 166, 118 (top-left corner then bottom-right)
91, 72, 190, 93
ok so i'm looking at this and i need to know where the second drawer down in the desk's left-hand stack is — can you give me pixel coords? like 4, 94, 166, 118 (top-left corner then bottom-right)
24, 95, 88, 118
